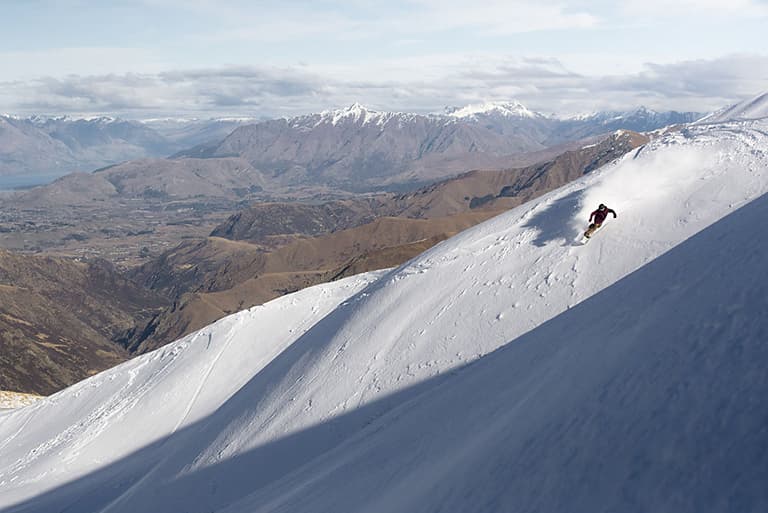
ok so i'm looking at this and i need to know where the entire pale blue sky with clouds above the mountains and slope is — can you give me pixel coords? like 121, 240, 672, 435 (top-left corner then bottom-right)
0, 0, 768, 119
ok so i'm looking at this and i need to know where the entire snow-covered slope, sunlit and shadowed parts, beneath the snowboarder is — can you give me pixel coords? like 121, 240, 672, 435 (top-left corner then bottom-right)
0, 117, 768, 513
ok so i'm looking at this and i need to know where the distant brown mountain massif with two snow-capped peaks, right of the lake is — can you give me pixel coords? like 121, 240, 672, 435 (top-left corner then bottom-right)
175, 103, 700, 192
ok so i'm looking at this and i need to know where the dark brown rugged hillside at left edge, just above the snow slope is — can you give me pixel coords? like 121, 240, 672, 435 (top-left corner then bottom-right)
0, 250, 164, 394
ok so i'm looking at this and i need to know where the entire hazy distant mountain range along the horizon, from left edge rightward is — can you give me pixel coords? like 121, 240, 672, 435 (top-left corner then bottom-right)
0, 102, 701, 185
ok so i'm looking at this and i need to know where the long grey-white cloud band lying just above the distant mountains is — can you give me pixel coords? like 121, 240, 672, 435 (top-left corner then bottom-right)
0, 55, 768, 117
